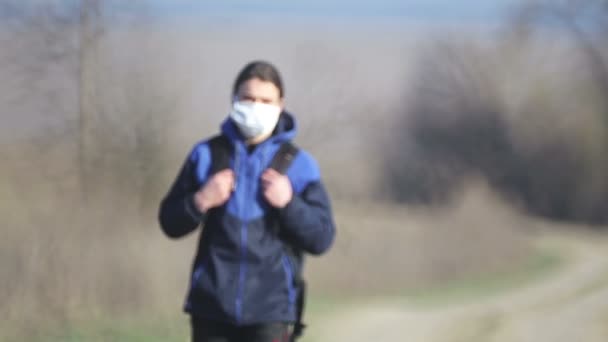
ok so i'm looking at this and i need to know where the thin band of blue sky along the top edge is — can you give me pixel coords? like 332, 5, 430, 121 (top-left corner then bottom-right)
112, 0, 521, 24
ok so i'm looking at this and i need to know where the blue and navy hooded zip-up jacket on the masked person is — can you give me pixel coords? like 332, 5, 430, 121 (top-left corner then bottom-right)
159, 112, 335, 325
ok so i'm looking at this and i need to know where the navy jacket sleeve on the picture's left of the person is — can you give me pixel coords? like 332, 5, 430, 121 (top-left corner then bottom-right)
158, 149, 206, 238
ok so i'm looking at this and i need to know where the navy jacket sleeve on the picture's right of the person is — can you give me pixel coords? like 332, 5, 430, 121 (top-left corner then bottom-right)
279, 154, 336, 255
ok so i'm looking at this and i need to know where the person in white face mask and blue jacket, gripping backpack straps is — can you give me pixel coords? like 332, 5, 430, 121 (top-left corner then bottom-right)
159, 61, 335, 342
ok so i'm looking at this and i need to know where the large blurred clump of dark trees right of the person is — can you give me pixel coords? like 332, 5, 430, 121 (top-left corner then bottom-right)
386, 1, 608, 224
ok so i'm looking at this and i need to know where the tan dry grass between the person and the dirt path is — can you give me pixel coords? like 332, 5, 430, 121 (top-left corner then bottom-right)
310, 179, 533, 295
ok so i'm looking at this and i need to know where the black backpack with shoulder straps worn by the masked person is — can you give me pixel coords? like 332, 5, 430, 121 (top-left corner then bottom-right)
208, 134, 306, 341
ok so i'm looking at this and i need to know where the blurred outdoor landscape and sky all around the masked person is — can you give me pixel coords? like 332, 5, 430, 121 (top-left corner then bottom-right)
0, 0, 608, 342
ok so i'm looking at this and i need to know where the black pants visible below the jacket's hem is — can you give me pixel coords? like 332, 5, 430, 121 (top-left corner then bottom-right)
190, 316, 289, 342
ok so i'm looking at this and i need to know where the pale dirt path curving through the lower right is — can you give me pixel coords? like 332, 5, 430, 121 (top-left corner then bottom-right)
311, 234, 608, 342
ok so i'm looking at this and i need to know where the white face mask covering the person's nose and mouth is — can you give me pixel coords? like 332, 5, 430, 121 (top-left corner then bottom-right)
230, 101, 281, 139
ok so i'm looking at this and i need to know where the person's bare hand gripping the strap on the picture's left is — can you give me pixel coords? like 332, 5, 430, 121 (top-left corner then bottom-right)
194, 169, 234, 213
